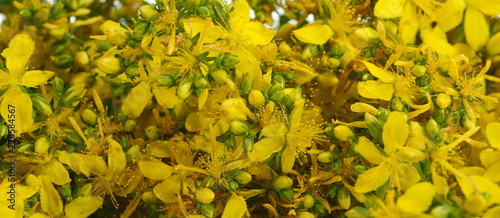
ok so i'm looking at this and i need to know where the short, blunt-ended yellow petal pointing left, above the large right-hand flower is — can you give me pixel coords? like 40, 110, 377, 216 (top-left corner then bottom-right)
358, 80, 394, 101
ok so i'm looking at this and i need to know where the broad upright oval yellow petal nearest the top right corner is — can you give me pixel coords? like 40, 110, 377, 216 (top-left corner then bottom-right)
464, 6, 490, 51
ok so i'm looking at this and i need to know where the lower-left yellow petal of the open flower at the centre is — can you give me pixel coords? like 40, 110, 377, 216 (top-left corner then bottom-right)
248, 136, 285, 162
